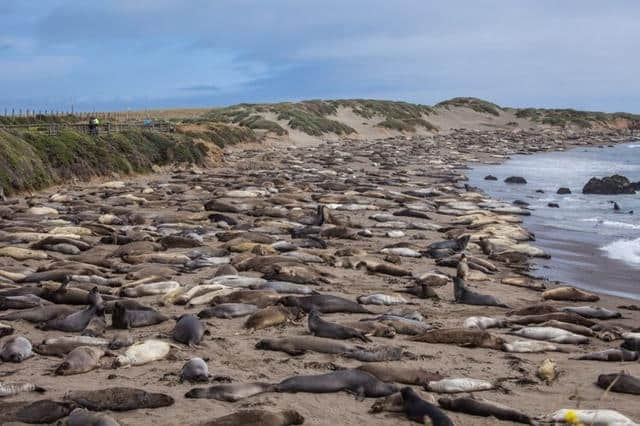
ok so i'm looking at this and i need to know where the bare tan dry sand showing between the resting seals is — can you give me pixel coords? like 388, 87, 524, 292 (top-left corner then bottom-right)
0, 125, 640, 425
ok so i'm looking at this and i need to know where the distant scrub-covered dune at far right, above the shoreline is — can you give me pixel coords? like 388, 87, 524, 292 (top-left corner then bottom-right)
516, 108, 640, 129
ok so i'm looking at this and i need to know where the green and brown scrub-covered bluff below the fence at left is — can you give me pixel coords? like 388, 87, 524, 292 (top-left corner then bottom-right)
0, 129, 208, 194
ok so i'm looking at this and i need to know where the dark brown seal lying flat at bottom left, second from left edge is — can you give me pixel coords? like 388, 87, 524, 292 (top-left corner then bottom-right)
64, 387, 175, 411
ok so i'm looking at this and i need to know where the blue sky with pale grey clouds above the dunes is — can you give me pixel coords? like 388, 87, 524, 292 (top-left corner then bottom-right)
0, 0, 640, 113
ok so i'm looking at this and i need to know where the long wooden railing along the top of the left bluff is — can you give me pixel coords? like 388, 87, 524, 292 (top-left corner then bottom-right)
0, 122, 176, 136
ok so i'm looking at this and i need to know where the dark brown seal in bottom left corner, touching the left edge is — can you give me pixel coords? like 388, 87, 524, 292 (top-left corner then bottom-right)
0, 399, 76, 424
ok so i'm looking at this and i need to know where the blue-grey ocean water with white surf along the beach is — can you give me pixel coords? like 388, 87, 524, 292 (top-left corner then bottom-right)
467, 143, 640, 300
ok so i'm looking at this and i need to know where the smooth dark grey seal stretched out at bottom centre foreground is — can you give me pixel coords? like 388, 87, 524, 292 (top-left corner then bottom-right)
275, 369, 398, 398
